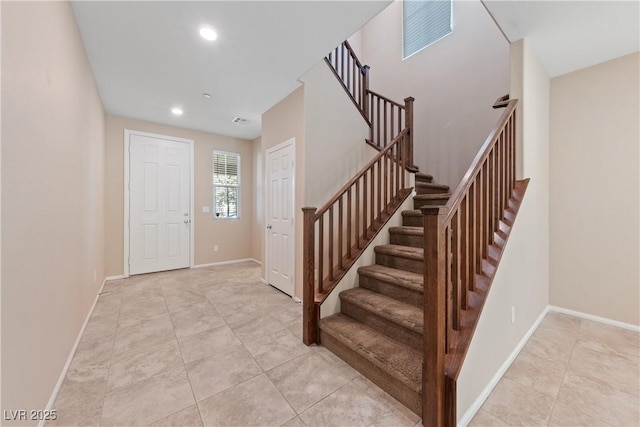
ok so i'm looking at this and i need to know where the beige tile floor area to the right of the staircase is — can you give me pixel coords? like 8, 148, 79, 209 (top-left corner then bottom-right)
469, 313, 640, 427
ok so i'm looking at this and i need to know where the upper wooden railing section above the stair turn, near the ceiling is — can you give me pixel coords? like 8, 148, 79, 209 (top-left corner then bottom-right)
325, 41, 418, 172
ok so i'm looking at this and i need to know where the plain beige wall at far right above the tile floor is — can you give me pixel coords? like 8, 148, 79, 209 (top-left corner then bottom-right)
550, 53, 640, 325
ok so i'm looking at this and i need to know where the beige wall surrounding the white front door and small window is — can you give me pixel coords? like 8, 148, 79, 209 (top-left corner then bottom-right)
106, 116, 253, 276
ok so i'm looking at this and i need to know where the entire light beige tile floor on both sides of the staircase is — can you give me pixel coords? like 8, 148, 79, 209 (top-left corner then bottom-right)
47, 263, 640, 427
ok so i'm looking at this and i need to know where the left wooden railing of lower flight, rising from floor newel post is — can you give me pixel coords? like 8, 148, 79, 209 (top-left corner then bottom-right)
302, 129, 413, 345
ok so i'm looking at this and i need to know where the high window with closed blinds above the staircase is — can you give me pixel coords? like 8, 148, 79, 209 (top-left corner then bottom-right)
402, 0, 453, 59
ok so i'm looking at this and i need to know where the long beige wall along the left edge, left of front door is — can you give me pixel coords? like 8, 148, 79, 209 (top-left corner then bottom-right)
1, 2, 105, 425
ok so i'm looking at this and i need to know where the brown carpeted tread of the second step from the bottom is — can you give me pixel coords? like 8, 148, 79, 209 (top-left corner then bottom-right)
340, 288, 424, 334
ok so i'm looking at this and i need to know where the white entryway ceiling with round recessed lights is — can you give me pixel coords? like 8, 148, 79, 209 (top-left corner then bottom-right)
73, 0, 391, 139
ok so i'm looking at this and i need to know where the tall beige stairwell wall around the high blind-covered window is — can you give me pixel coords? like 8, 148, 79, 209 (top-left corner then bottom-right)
360, 0, 509, 187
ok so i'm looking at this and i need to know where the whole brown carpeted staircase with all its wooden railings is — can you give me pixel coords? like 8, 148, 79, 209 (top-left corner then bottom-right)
302, 42, 528, 426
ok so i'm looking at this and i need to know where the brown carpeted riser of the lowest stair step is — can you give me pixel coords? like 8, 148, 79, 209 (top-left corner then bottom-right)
320, 330, 422, 416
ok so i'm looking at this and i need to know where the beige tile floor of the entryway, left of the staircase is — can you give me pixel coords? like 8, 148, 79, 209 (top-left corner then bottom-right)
47, 263, 419, 427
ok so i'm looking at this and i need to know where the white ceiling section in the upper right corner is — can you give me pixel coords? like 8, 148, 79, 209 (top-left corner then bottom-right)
484, 0, 640, 77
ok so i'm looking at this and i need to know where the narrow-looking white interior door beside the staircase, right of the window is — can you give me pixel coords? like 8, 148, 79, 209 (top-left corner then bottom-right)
267, 141, 295, 296
